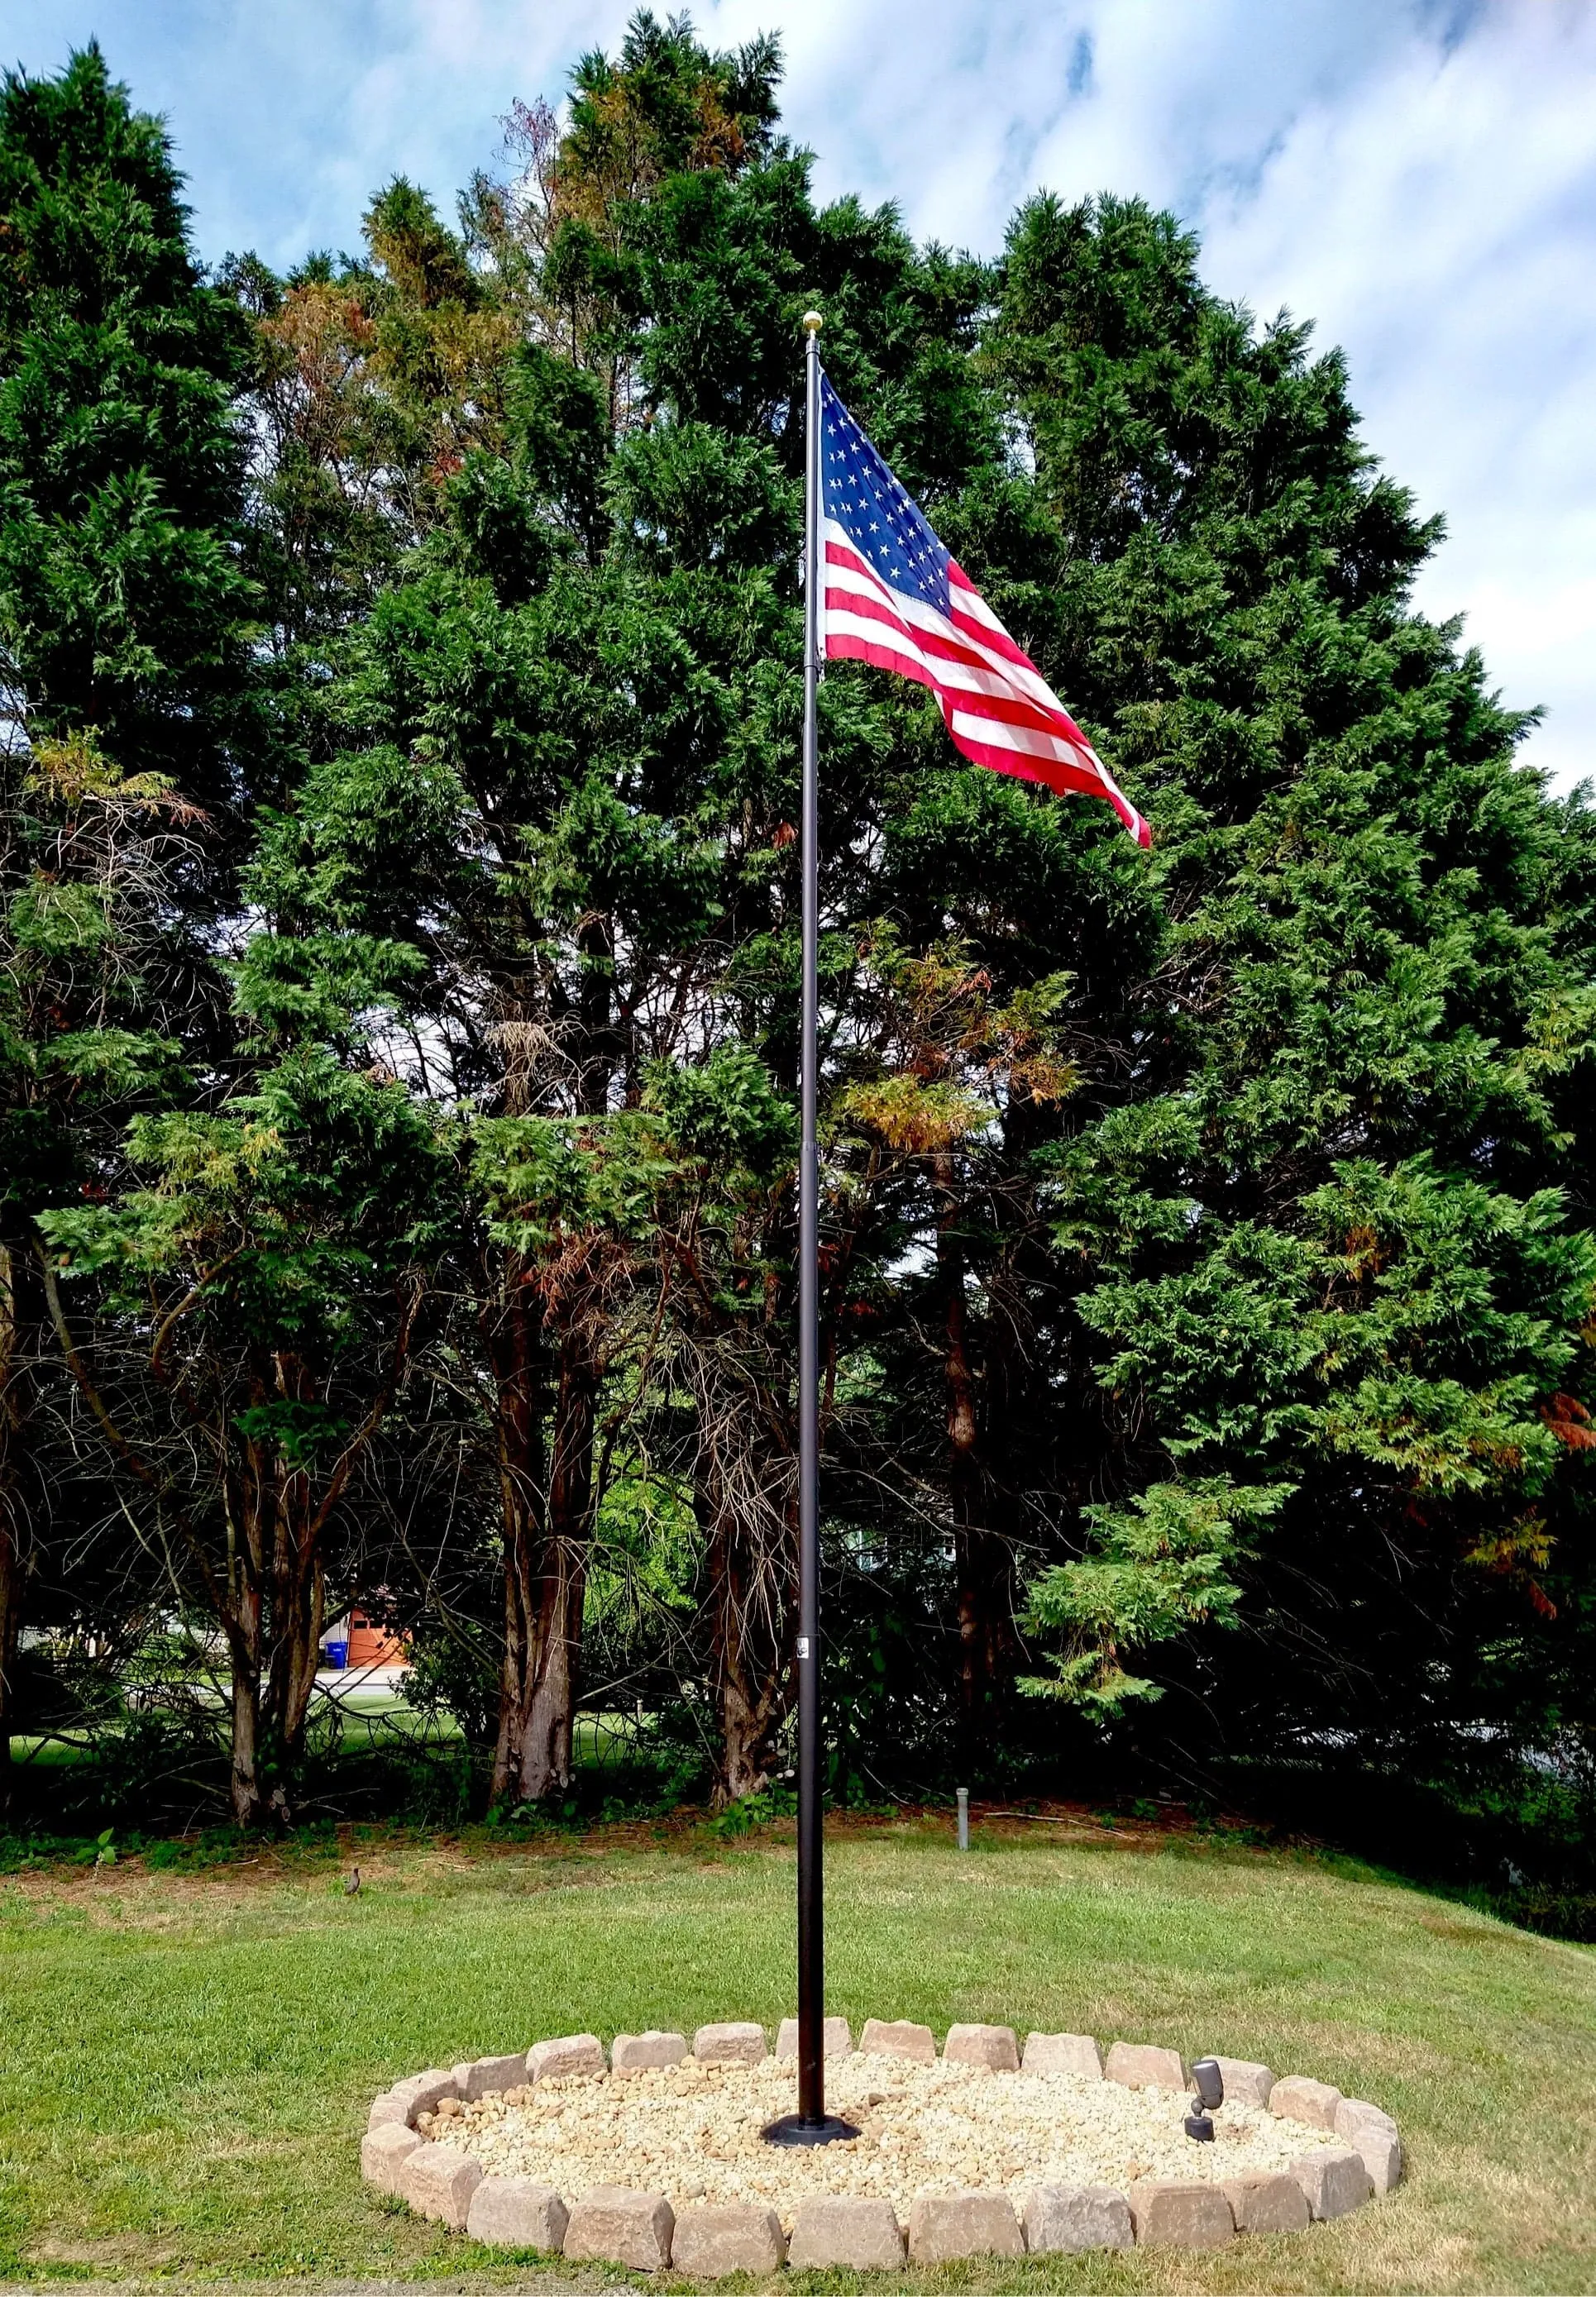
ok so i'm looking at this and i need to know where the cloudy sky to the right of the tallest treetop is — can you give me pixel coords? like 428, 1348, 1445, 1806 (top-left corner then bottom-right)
675, 0, 1596, 783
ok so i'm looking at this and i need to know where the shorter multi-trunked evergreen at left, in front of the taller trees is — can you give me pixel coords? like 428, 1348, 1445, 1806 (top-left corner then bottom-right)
39, 992, 448, 1827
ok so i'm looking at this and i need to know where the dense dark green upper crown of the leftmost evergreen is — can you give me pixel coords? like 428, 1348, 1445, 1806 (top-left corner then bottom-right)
0, 46, 252, 797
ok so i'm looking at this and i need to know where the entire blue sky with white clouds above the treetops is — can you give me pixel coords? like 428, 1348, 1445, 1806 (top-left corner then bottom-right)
12, 0, 1596, 783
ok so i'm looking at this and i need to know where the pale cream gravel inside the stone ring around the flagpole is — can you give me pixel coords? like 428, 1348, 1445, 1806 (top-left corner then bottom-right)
429, 2054, 1341, 2228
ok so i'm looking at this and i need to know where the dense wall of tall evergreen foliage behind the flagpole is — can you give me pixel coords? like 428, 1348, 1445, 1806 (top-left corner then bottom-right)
0, 14, 1596, 1865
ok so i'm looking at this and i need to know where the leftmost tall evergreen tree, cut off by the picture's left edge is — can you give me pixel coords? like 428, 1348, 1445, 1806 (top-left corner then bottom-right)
0, 48, 251, 1796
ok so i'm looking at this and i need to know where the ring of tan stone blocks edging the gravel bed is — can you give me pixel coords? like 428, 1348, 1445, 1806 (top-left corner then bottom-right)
361, 2019, 1403, 2279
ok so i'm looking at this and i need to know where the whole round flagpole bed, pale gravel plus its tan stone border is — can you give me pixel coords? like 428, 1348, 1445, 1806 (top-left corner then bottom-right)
361, 2017, 1401, 2279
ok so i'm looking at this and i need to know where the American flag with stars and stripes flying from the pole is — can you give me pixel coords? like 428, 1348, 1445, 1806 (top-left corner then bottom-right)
820, 372, 1153, 845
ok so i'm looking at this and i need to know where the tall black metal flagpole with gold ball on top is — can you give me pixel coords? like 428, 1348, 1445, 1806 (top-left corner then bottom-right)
765, 310, 859, 2146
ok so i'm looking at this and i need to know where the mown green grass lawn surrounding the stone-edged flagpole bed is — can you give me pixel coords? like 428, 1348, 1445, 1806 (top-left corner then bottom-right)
0, 1819, 1596, 2292
